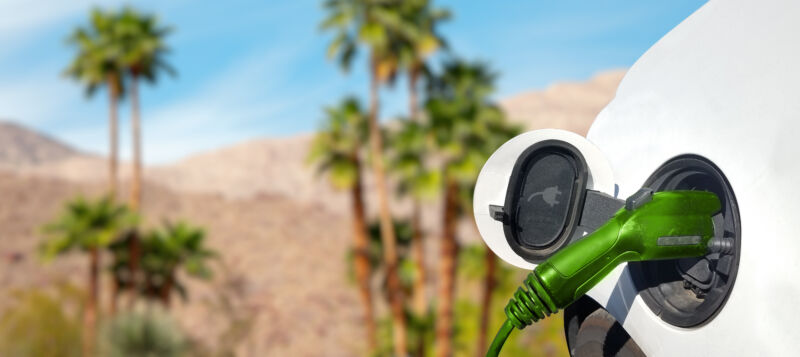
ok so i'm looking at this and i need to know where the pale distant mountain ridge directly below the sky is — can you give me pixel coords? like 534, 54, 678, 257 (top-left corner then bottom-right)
0, 70, 625, 202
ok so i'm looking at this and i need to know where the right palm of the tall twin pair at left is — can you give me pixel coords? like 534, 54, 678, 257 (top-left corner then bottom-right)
113, 7, 175, 210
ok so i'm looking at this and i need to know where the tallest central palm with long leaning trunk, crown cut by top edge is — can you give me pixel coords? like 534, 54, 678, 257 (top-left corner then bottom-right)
321, 0, 407, 356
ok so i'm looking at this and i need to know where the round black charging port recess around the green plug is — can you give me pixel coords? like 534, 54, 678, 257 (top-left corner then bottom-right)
629, 155, 741, 327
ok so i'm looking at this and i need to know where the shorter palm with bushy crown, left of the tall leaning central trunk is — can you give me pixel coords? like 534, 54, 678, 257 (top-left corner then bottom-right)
308, 97, 377, 350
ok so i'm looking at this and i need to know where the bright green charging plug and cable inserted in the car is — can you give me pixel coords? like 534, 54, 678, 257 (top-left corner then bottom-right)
486, 189, 720, 357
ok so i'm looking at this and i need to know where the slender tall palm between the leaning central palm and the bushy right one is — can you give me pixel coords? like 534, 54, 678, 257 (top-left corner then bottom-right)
396, 0, 450, 315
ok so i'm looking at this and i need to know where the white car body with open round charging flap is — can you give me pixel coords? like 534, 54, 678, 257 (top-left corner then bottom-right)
474, 0, 800, 356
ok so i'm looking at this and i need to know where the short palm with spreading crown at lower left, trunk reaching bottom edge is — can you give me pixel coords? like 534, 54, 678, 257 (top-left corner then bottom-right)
40, 196, 137, 356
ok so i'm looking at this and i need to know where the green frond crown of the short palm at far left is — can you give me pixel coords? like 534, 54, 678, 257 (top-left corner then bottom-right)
39, 197, 138, 260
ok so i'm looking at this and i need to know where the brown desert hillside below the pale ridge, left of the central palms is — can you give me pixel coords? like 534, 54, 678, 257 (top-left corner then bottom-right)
0, 172, 363, 356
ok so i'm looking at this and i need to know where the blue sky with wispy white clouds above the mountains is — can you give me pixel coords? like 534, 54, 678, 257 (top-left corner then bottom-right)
0, 0, 704, 164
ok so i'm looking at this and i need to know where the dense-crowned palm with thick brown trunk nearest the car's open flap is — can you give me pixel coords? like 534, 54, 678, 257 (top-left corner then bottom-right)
425, 60, 519, 356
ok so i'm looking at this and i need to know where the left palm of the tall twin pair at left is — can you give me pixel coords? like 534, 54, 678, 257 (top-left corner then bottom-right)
64, 9, 124, 197
